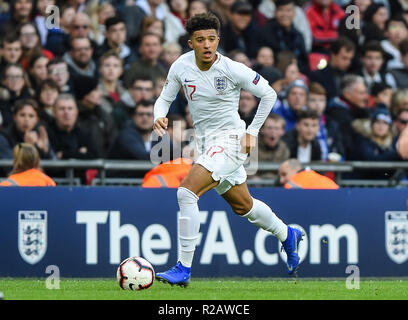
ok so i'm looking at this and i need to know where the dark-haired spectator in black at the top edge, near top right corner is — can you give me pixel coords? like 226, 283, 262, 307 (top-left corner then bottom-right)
362, 2, 388, 42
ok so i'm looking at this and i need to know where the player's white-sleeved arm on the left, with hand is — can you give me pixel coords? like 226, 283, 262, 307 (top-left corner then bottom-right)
153, 64, 181, 137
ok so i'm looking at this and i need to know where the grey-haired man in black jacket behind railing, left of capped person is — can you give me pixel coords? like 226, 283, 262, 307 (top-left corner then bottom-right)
48, 93, 97, 159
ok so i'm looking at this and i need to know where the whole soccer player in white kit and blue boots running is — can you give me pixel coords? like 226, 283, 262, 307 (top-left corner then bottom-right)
153, 13, 303, 286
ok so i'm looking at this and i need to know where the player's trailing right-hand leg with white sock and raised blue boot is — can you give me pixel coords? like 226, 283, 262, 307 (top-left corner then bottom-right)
222, 183, 303, 274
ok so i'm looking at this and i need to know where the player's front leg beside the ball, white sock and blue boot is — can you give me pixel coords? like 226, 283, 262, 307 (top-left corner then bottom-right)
156, 164, 218, 286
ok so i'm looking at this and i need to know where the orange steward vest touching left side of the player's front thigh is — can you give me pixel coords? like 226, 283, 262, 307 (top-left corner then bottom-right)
142, 158, 193, 188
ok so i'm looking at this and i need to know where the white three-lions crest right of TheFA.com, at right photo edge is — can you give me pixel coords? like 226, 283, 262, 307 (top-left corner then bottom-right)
385, 211, 408, 264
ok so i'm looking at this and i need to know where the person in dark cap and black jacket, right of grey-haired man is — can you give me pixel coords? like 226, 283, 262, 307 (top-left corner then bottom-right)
75, 77, 116, 158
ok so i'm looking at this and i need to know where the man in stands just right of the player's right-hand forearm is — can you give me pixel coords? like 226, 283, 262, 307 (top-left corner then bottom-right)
257, 113, 290, 179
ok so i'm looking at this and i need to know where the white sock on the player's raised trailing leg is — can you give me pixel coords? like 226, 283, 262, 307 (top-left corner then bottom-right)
242, 198, 288, 242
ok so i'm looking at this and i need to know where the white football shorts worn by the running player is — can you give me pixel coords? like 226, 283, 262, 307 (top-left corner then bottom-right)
196, 130, 248, 195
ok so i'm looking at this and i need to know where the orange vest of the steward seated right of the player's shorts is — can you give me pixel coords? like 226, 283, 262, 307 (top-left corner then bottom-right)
285, 169, 340, 189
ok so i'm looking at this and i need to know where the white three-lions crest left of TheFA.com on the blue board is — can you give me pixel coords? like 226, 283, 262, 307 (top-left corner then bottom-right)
18, 211, 47, 264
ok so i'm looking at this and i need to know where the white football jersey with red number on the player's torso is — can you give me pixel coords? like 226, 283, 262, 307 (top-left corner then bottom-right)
155, 51, 274, 149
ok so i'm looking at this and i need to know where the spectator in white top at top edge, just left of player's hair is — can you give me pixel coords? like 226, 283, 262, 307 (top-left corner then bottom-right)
164, 0, 188, 43
